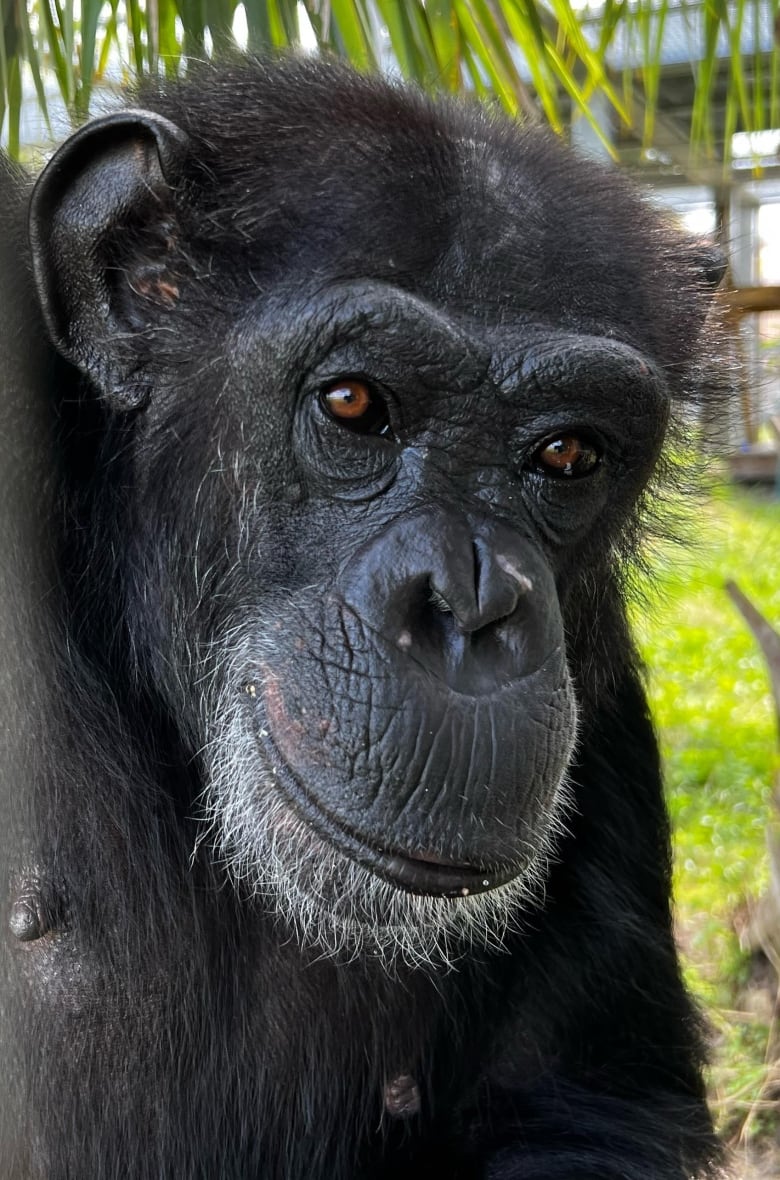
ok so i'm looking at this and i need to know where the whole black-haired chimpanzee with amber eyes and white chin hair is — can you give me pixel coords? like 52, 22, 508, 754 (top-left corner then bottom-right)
0, 58, 728, 1180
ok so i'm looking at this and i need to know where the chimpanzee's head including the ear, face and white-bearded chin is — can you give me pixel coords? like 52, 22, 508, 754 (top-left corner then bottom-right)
31, 60, 715, 962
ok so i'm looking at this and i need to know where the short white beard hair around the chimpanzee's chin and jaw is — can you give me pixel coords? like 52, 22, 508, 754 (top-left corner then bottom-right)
196, 637, 572, 974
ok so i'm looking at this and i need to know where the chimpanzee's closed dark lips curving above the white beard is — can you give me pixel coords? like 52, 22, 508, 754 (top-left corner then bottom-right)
248, 721, 525, 898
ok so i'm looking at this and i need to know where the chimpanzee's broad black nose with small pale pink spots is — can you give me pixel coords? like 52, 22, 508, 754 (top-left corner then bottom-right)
339, 511, 561, 694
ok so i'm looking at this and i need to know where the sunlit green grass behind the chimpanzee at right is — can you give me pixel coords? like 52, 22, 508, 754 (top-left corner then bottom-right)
635, 476, 780, 1141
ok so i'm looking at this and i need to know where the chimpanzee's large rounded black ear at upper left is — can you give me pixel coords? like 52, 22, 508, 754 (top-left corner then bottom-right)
30, 110, 188, 409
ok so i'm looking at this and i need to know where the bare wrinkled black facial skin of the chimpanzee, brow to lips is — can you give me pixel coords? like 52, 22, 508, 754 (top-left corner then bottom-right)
191, 283, 666, 894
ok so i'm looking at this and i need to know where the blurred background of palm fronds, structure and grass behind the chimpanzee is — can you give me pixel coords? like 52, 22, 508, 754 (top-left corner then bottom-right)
0, 0, 780, 1178
